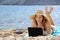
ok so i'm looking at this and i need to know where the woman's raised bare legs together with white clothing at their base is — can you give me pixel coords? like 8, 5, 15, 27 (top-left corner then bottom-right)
46, 7, 55, 32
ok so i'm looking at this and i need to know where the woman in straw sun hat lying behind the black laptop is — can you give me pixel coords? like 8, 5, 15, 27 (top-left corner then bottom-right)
30, 8, 53, 34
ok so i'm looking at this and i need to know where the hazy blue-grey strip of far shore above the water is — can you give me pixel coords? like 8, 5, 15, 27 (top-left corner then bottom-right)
0, 0, 60, 5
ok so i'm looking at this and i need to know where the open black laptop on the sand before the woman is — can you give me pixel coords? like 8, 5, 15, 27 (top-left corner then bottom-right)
28, 27, 43, 37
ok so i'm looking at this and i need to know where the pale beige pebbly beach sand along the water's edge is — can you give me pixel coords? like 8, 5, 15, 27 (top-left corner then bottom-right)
0, 29, 60, 40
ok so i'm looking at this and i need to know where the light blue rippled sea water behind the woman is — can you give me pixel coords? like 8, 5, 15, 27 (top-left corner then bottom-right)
0, 5, 60, 29
